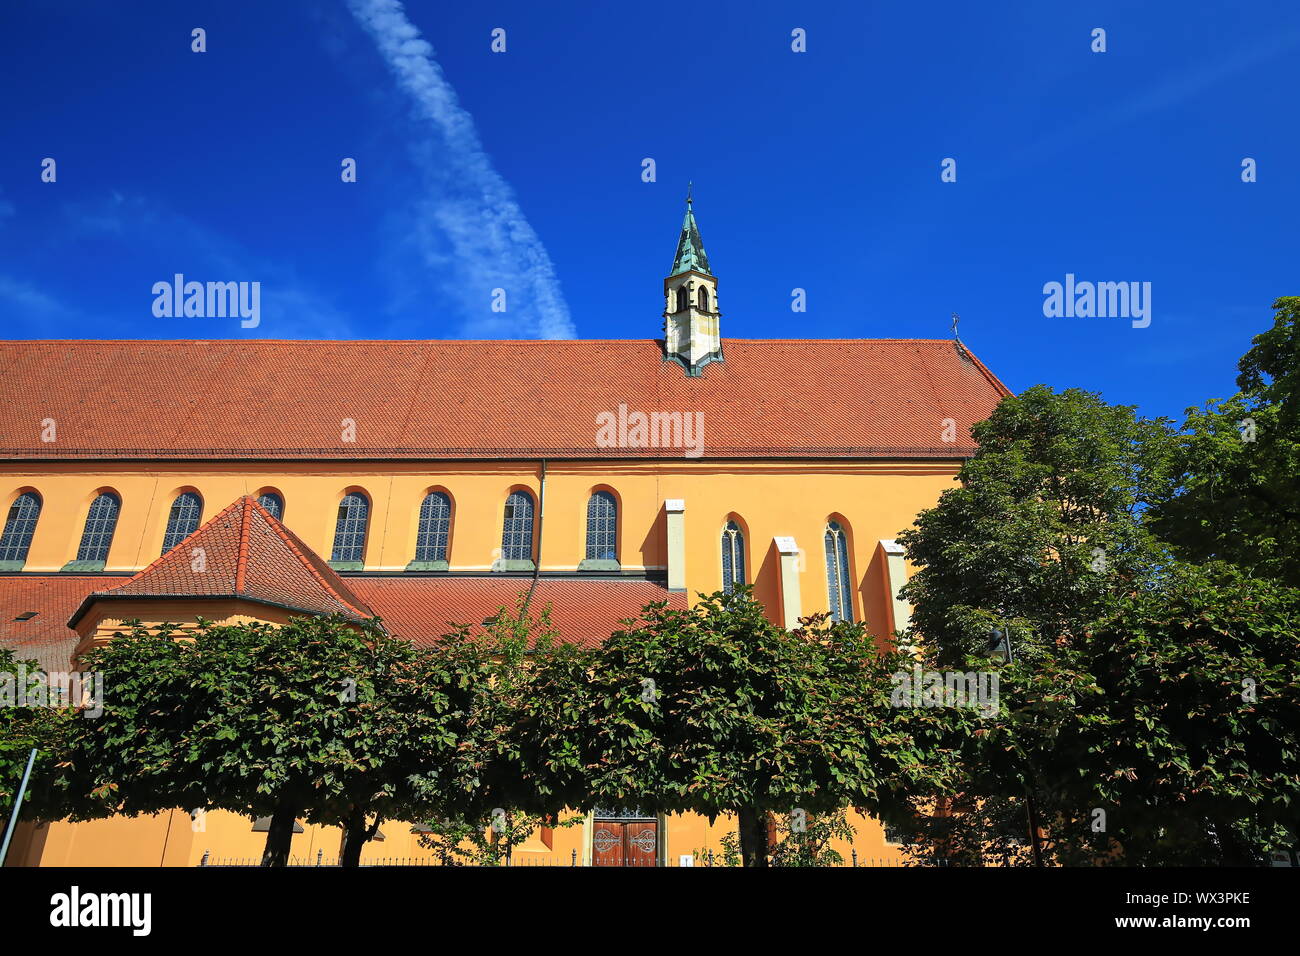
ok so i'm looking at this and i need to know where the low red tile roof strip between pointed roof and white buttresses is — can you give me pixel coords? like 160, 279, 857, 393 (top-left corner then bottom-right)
350, 576, 686, 646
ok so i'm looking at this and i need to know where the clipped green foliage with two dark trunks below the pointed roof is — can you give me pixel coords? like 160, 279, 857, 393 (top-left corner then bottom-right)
53, 618, 491, 866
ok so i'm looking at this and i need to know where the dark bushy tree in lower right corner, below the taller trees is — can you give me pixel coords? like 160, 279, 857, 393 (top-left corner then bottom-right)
904, 564, 1300, 865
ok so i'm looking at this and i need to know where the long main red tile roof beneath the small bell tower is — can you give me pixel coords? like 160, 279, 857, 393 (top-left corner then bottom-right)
0, 339, 1009, 459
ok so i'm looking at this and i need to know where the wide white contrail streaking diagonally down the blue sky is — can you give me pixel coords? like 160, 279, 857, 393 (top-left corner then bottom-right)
348, 0, 575, 338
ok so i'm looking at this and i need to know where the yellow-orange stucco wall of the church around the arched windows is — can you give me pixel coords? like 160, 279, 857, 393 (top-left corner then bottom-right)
0, 459, 957, 865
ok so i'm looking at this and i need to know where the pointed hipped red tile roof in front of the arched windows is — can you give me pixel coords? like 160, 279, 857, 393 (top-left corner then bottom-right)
69, 496, 373, 624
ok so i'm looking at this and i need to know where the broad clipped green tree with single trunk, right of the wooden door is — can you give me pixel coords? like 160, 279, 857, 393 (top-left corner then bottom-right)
508, 589, 972, 866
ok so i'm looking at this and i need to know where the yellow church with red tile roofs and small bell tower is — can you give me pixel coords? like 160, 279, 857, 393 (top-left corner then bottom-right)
0, 200, 1010, 866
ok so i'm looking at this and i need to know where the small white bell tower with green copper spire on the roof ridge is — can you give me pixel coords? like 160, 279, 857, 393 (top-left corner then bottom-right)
663, 189, 723, 376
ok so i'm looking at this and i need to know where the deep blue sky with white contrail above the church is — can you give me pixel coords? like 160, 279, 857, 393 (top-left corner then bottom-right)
0, 0, 1300, 426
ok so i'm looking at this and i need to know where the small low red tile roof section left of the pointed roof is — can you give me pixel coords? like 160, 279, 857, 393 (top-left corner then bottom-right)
0, 574, 129, 671
